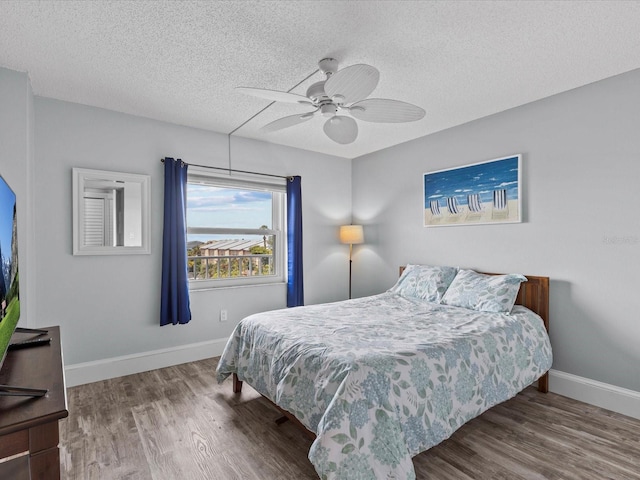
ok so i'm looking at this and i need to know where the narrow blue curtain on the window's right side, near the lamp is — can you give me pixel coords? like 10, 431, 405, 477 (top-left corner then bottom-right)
287, 177, 304, 307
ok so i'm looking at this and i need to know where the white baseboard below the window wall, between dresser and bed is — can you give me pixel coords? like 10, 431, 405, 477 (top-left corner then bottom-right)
64, 338, 227, 387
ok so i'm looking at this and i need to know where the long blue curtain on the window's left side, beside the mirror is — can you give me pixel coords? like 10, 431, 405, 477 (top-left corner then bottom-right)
160, 158, 191, 326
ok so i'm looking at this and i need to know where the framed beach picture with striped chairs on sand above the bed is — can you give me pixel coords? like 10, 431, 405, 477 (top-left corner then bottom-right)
423, 155, 522, 227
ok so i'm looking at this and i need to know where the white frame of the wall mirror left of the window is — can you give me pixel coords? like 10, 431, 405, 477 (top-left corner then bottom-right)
73, 168, 151, 255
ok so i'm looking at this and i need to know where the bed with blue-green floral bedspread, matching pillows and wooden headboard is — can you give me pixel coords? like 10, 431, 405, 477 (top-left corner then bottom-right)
217, 265, 552, 480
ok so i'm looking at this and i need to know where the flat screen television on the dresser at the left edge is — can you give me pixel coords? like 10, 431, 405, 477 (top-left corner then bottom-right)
0, 176, 47, 397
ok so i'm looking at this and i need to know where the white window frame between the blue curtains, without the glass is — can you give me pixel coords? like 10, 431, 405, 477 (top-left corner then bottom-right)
186, 167, 287, 291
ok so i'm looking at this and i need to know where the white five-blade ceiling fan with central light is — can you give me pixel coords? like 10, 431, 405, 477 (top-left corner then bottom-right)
236, 58, 425, 144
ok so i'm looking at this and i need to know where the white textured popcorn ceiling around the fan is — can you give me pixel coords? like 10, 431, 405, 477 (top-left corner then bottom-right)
0, 0, 640, 158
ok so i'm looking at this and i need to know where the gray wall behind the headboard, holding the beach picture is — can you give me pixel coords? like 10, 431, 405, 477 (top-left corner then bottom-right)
352, 70, 640, 391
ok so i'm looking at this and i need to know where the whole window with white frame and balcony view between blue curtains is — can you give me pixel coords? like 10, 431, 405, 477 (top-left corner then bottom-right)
187, 170, 286, 289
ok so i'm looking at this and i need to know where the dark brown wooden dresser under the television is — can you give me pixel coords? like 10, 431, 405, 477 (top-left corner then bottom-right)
0, 327, 69, 480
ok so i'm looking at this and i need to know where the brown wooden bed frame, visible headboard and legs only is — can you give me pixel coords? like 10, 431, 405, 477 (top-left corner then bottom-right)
233, 266, 549, 420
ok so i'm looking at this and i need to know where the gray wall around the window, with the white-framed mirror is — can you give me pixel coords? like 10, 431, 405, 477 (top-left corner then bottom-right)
33, 97, 351, 365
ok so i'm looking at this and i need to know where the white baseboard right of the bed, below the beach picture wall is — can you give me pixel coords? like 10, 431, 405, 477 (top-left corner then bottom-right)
549, 370, 640, 419
